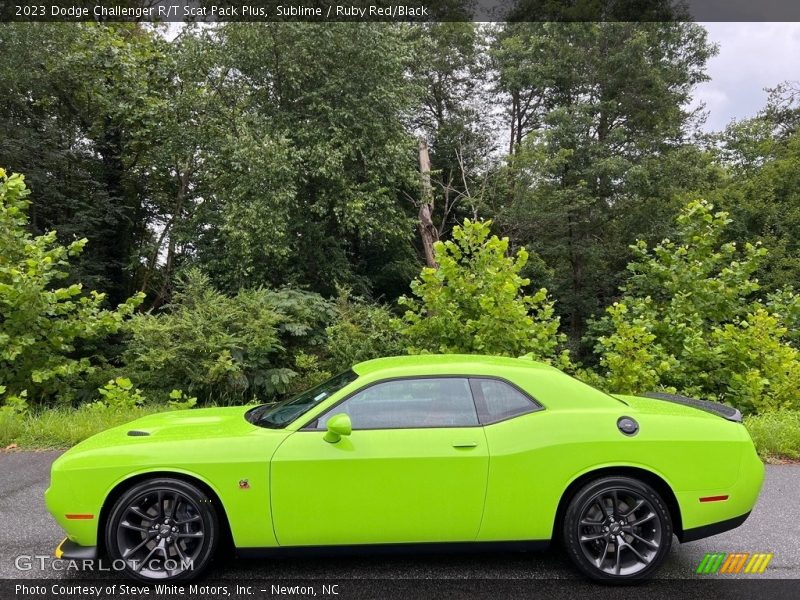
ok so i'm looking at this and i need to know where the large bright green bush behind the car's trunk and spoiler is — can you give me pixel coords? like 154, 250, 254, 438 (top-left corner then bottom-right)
595, 201, 800, 411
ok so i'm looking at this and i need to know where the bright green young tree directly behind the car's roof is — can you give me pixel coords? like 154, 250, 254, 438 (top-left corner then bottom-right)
397, 219, 568, 365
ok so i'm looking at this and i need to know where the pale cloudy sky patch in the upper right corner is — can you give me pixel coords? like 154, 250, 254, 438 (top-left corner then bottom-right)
694, 23, 800, 131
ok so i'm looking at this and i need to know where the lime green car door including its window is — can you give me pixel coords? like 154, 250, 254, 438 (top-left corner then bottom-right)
270, 377, 489, 546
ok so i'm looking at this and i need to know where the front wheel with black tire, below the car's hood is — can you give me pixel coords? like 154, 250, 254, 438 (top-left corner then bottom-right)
105, 478, 220, 582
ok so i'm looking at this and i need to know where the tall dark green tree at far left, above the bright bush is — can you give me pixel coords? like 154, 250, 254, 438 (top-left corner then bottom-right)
0, 23, 184, 302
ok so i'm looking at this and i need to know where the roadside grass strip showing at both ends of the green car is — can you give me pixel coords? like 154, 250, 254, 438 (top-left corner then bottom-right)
0, 404, 800, 460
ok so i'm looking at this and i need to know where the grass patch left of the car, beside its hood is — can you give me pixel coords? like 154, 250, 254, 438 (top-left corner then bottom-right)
0, 405, 171, 450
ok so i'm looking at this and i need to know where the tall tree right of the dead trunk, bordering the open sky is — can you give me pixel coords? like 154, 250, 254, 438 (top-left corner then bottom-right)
490, 22, 715, 344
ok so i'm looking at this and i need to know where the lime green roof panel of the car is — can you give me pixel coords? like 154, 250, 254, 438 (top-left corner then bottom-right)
353, 354, 558, 375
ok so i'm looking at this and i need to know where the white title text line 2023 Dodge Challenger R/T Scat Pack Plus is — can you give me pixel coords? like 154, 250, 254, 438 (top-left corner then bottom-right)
14, 3, 429, 21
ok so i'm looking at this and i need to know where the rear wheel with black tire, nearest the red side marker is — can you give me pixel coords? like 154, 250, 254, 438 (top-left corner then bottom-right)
562, 477, 672, 584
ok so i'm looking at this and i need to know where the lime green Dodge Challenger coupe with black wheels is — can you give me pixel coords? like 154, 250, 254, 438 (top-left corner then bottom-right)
45, 355, 764, 582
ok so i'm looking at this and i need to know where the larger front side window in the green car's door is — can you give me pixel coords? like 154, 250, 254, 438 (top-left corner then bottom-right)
316, 377, 478, 429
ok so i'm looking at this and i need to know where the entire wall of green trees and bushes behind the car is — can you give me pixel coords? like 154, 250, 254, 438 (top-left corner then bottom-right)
0, 23, 800, 414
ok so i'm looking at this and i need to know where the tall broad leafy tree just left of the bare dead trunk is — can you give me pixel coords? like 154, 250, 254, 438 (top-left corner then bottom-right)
191, 23, 417, 295
